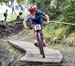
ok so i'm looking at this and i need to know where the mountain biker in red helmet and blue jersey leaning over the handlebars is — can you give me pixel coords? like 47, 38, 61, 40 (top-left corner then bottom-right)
23, 5, 49, 46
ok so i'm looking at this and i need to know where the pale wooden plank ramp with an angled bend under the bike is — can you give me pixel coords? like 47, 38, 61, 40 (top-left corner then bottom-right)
8, 40, 63, 62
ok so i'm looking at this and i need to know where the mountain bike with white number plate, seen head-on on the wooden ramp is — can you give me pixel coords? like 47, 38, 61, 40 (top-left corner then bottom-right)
33, 24, 45, 58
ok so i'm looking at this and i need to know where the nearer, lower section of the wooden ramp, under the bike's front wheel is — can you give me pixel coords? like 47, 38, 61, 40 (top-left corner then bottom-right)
20, 48, 62, 62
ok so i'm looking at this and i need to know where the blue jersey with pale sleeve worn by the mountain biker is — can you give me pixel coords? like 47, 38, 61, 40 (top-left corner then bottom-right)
25, 9, 45, 24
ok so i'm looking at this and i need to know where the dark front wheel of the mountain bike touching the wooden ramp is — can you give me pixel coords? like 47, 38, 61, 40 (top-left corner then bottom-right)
37, 32, 45, 58
